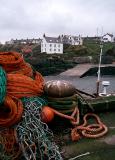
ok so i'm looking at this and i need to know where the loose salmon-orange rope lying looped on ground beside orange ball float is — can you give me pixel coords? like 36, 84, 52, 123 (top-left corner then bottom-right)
44, 106, 108, 141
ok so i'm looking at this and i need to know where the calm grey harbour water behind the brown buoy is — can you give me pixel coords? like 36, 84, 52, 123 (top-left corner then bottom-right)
44, 75, 115, 93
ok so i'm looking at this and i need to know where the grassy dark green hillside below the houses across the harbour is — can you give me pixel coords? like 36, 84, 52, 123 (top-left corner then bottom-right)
0, 40, 115, 75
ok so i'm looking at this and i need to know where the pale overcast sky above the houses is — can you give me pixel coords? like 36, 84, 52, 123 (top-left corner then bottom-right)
0, 0, 115, 43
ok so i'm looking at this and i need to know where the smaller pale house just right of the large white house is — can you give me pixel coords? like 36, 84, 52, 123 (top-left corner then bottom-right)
61, 35, 83, 45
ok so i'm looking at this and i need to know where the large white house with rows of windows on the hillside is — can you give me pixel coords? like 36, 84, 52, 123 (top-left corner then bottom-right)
41, 34, 63, 54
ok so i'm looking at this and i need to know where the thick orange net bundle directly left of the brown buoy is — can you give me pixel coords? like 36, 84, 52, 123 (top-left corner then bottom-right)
7, 72, 44, 98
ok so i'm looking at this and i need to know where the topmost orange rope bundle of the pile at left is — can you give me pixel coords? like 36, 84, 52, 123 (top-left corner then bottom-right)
0, 52, 33, 77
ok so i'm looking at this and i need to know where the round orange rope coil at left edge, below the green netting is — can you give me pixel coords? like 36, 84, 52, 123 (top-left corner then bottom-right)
0, 96, 23, 127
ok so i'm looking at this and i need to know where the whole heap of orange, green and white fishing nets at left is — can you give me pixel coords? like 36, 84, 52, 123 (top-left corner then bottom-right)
0, 52, 62, 160
